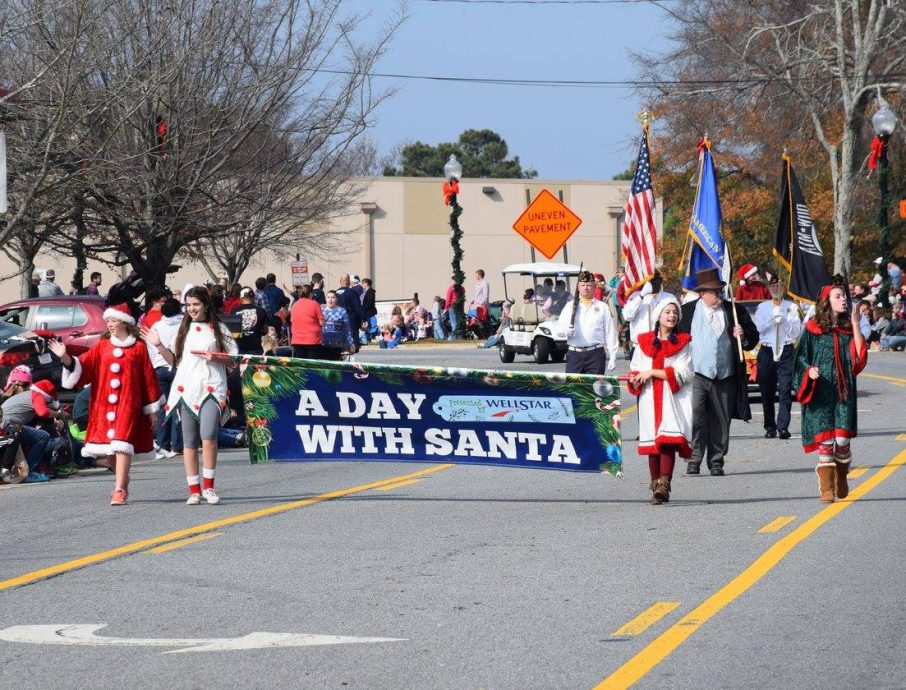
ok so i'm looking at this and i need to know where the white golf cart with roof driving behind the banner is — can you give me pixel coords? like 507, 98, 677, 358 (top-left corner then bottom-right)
497, 261, 580, 364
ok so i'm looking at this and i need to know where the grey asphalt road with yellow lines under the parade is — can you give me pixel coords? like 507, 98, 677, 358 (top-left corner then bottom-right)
0, 346, 906, 689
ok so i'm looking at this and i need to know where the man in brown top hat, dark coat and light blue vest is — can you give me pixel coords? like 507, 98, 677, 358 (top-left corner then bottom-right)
679, 268, 758, 477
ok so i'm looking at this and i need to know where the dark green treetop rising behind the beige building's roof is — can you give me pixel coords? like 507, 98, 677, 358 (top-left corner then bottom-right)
384, 129, 538, 179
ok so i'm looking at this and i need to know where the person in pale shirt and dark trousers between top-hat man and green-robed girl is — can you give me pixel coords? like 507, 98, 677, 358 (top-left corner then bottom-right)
754, 276, 802, 439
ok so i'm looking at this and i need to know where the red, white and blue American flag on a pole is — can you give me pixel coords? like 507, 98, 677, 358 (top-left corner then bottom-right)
620, 130, 657, 294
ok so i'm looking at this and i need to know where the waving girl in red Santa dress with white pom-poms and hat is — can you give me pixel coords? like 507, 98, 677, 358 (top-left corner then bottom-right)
50, 304, 161, 506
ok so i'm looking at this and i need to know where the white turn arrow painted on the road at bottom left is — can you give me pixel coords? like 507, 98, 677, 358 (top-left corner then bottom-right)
0, 623, 406, 654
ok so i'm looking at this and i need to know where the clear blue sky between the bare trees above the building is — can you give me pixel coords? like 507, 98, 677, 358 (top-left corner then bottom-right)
349, 0, 666, 179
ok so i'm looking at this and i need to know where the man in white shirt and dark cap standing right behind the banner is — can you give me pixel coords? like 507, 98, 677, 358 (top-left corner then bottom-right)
558, 271, 620, 376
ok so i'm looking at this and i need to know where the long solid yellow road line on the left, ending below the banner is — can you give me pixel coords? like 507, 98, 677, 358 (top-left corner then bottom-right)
0, 464, 454, 591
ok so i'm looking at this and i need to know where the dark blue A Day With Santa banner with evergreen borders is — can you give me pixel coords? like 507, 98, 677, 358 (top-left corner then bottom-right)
233, 355, 622, 475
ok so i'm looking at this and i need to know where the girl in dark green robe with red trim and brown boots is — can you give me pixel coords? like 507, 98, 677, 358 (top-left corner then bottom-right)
793, 285, 868, 503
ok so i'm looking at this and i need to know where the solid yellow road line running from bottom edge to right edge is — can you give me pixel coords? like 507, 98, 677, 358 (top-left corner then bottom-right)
595, 451, 906, 690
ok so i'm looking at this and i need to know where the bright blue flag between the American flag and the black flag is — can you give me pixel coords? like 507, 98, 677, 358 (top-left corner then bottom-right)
683, 143, 730, 290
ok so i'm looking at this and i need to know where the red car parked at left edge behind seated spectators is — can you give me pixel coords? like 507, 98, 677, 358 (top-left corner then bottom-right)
0, 295, 107, 355
